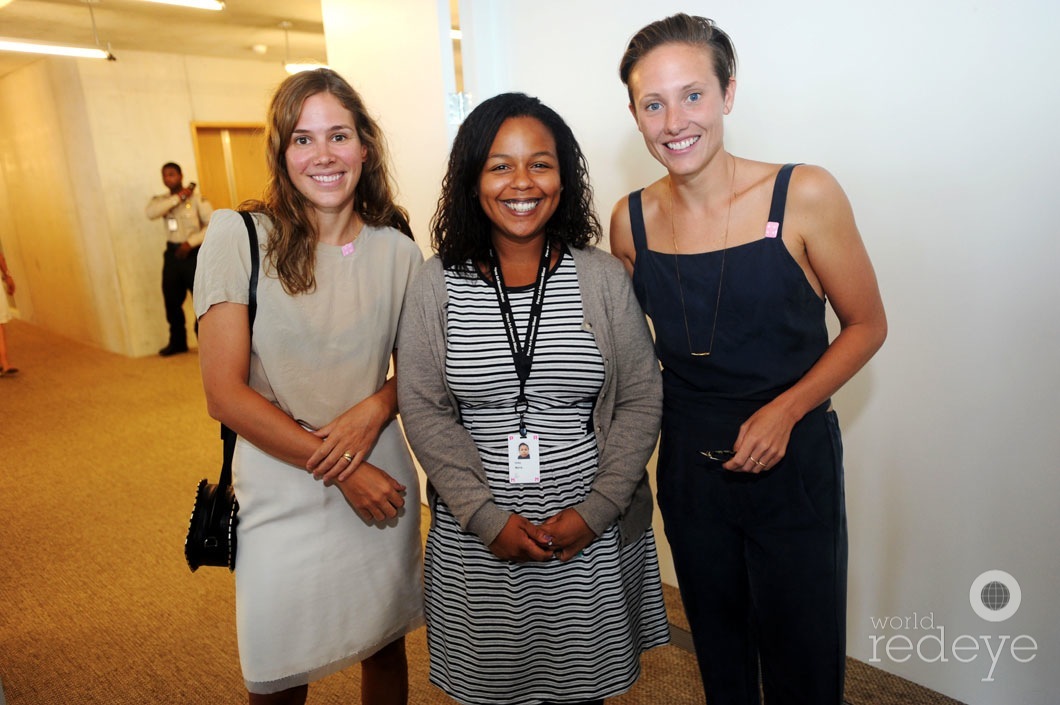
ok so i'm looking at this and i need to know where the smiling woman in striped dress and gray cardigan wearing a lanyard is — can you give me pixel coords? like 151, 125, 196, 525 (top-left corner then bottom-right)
399, 93, 669, 704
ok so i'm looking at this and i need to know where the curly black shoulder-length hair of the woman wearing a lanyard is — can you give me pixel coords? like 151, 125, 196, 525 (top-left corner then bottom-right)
430, 93, 602, 268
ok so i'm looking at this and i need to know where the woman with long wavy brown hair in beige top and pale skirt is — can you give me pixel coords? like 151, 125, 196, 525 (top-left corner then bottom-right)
195, 69, 423, 705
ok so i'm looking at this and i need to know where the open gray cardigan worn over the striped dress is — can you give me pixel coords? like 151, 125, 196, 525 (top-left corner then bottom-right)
398, 247, 663, 546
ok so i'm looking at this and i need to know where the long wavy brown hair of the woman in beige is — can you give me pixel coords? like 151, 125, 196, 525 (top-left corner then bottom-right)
239, 69, 412, 295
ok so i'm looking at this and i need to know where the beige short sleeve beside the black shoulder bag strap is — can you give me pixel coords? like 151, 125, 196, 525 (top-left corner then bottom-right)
193, 209, 266, 318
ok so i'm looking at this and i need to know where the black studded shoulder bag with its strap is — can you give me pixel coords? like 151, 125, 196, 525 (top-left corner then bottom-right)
184, 212, 258, 572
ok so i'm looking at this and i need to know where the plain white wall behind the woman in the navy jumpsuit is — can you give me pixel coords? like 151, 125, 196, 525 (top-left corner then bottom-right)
460, 0, 1060, 705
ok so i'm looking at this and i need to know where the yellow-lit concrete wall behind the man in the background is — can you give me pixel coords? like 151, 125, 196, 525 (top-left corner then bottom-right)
0, 52, 285, 355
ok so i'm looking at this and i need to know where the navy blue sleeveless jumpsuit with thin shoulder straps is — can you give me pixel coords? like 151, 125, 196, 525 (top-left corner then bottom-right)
630, 164, 847, 705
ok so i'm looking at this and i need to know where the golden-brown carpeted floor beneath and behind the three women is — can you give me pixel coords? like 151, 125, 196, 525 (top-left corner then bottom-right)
0, 321, 960, 705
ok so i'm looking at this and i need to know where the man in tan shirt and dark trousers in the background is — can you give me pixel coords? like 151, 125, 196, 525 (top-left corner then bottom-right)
146, 161, 213, 357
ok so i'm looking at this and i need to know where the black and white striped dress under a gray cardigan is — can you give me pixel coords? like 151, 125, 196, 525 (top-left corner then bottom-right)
425, 253, 668, 705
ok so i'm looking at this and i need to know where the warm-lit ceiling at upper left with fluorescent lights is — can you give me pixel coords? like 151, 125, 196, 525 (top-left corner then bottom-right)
0, 0, 328, 76
